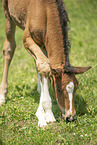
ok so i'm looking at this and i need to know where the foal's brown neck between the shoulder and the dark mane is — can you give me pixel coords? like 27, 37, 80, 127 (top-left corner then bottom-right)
45, 3, 65, 68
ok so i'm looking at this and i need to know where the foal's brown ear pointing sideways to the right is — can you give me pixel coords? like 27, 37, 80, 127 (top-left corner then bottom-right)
64, 66, 91, 74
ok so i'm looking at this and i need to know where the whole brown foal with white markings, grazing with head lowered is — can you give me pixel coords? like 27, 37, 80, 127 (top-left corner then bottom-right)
0, 0, 90, 126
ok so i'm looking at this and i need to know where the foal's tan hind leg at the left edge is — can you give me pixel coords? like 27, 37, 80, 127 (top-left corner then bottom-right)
0, 18, 16, 105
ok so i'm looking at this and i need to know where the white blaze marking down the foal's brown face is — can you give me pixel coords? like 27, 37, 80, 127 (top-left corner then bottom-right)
66, 82, 74, 114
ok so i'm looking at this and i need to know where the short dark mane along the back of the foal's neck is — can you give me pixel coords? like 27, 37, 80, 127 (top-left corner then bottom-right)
56, 0, 70, 66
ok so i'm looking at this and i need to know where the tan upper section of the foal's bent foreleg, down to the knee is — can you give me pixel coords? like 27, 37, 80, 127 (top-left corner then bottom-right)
23, 30, 50, 75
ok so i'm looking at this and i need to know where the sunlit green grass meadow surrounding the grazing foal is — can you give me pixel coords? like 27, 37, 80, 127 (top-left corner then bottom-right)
0, 0, 97, 145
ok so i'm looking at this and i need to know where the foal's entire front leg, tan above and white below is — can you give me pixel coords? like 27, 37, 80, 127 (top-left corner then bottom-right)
23, 29, 55, 127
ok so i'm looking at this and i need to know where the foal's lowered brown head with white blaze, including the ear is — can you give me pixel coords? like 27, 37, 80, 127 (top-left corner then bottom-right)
52, 67, 90, 121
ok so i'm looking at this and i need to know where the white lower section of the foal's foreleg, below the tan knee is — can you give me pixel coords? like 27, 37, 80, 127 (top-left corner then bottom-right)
36, 77, 56, 127
